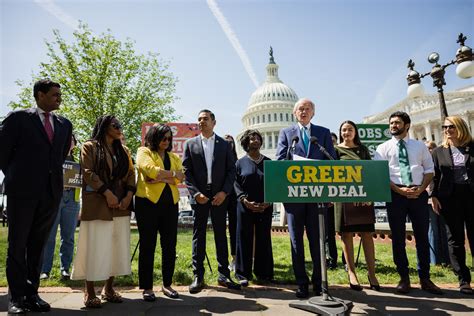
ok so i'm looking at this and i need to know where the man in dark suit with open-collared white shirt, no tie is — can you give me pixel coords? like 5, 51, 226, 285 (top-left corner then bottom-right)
183, 110, 240, 293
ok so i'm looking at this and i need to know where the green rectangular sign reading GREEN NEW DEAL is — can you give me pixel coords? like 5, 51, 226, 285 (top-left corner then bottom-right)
264, 160, 391, 203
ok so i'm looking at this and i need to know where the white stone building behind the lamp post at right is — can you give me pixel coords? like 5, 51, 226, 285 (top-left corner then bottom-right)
364, 85, 474, 144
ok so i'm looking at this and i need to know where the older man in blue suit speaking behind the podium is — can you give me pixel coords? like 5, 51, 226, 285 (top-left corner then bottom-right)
276, 99, 336, 298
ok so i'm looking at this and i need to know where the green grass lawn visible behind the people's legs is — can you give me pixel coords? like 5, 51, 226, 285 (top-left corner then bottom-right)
0, 227, 472, 287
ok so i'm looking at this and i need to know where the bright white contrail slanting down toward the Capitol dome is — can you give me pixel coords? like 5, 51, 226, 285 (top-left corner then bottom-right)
207, 0, 258, 88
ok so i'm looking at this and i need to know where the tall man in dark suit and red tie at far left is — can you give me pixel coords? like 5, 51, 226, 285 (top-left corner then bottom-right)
0, 79, 72, 314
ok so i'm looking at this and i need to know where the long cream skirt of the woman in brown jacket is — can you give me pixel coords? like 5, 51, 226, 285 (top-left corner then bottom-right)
71, 216, 131, 281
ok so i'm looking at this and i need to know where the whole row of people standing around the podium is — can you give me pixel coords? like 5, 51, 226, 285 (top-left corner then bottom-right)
0, 79, 474, 314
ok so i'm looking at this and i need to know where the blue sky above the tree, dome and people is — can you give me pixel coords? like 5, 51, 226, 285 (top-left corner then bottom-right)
0, 0, 474, 135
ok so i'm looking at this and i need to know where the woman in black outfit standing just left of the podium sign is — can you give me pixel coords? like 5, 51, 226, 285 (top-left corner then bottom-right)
235, 130, 273, 286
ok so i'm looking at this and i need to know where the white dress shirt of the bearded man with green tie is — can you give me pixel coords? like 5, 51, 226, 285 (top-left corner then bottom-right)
374, 136, 434, 185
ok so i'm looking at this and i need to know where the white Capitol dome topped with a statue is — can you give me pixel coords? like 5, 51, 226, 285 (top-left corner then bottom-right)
237, 47, 298, 159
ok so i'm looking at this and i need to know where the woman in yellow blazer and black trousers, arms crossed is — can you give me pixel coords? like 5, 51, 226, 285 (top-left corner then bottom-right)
135, 124, 184, 301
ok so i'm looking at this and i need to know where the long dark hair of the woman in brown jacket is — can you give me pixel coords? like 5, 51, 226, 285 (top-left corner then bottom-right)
90, 115, 130, 182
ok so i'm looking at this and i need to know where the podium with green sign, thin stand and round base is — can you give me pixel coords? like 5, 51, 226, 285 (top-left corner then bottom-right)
264, 160, 391, 315
